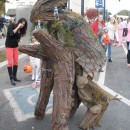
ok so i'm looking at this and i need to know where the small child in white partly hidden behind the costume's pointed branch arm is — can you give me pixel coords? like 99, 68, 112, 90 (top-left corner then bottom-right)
30, 36, 40, 81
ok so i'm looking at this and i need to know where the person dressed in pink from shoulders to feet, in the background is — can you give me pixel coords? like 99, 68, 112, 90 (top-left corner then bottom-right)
118, 18, 124, 47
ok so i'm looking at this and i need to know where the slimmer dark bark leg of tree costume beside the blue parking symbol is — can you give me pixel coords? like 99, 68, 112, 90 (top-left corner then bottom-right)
34, 60, 54, 119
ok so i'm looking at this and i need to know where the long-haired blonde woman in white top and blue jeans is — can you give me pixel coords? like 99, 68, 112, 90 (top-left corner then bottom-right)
106, 17, 115, 62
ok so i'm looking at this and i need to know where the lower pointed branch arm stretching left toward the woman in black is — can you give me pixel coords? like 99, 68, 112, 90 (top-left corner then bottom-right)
19, 45, 47, 59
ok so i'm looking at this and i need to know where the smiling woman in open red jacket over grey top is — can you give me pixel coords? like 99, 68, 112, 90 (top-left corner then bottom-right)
91, 14, 105, 72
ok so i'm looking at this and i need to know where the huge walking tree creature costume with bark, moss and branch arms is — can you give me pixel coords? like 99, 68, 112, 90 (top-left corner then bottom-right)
19, 0, 119, 130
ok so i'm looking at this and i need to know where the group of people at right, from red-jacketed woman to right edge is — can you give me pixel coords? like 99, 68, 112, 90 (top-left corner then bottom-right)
87, 14, 130, 72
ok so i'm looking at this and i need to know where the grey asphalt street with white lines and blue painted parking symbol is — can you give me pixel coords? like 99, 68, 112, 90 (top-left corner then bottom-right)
0, 38, 130, 130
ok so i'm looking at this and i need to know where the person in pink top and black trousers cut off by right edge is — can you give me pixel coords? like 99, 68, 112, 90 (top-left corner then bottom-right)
126, 17, 130, 67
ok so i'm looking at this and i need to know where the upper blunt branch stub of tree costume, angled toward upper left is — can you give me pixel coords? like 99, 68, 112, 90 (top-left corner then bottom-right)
33, 29, 64, 61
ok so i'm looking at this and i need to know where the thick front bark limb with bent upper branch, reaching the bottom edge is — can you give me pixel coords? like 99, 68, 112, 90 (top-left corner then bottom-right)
34, 30, 75, 130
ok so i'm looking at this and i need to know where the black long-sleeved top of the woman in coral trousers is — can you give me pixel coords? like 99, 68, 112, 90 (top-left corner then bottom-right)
5, 23, 21, 48
